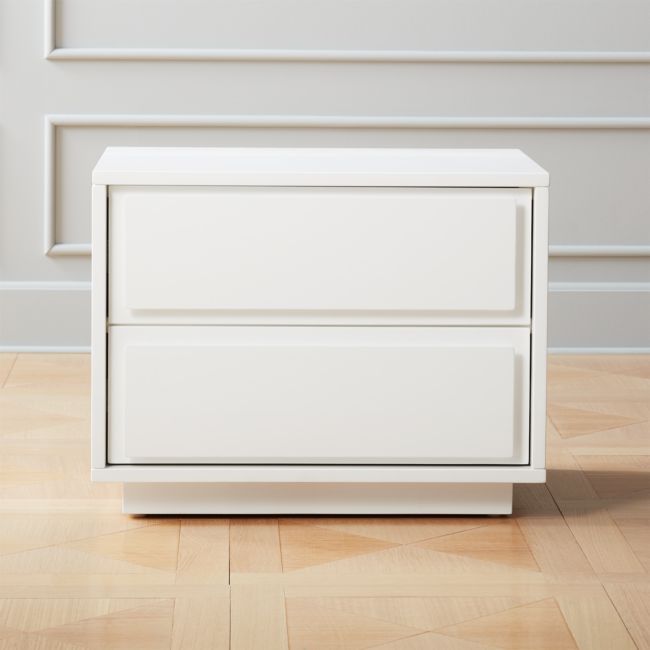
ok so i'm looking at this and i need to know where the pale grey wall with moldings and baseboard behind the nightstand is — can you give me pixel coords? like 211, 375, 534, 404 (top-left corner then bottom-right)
0, 0, 650, 349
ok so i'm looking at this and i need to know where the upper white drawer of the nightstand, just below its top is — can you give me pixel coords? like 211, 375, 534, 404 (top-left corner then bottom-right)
109, 186, 531, 325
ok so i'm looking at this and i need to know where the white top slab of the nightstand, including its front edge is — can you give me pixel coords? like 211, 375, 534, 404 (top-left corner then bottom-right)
92, 147, 549, 187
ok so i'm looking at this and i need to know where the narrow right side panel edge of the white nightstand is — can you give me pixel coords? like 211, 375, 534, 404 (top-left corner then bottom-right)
530, 187, 548, 469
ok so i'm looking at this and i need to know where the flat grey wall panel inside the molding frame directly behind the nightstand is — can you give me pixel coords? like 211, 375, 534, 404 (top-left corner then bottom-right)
53, 123, 650, 252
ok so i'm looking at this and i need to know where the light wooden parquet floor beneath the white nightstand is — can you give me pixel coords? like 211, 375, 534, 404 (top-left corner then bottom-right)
0, 354, 650, 650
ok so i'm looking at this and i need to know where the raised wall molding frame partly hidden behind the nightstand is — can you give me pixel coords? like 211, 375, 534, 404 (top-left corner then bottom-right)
43, 114, 650, 257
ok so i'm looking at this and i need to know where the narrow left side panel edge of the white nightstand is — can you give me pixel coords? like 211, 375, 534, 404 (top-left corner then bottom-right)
90, 185, 108, 467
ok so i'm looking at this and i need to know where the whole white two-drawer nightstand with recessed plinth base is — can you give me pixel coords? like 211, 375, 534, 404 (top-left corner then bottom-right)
92, 148, 548, 514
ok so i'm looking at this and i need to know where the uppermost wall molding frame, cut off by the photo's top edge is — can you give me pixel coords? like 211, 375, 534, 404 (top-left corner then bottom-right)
43, 0, 650, 64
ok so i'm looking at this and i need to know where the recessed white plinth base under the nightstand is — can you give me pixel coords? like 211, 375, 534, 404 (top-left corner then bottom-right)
123, 483, 512, 515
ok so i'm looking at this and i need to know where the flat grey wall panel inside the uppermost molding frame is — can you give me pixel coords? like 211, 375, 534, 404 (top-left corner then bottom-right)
54, 0, 648, 52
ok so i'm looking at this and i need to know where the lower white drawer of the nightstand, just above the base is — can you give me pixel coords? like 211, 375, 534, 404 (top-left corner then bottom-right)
108, 326, 530, 465
